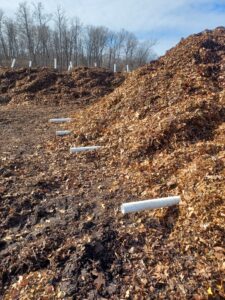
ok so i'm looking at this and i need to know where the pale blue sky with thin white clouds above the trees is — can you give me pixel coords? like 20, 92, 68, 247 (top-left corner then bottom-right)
0, 0, 225, 55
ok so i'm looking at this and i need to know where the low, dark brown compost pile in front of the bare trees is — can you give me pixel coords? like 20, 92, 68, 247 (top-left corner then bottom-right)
0, 67, 124, 105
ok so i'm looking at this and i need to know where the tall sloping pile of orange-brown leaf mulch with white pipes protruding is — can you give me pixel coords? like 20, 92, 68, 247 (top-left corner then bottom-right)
64, 28, 225, 297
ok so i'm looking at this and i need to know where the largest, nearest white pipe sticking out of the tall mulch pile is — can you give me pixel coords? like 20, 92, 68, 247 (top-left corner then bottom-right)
121, 196, 180, 214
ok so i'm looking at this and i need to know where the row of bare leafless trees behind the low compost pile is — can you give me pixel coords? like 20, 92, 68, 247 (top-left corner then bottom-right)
0, 2, 154, 70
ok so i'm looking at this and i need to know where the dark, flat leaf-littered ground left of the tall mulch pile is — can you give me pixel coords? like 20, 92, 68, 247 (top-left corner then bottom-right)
0, 106, 135, 299
